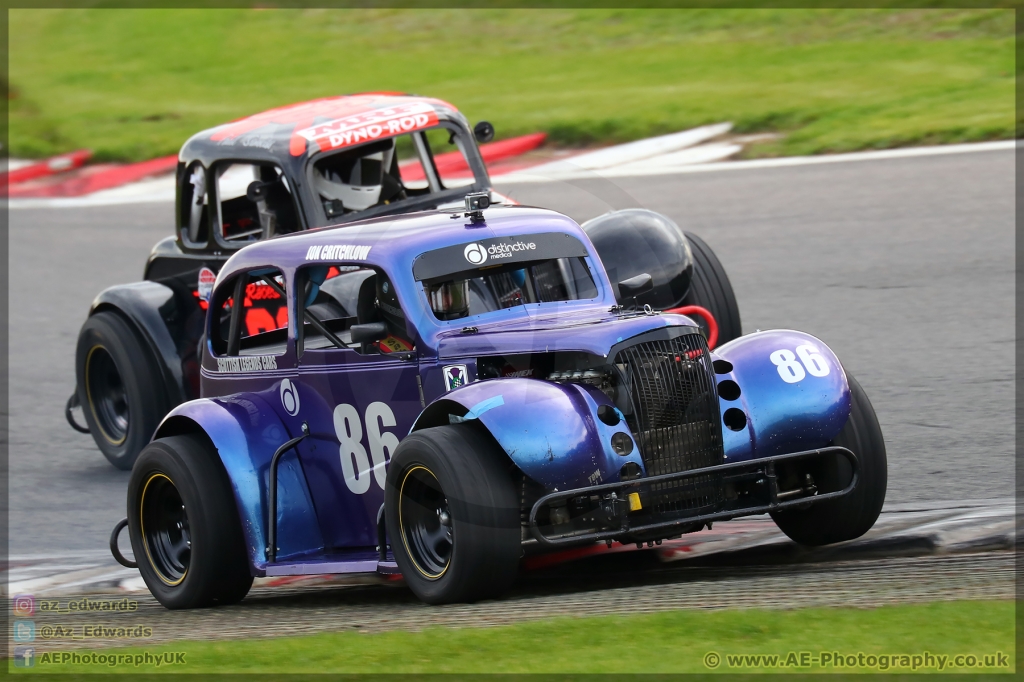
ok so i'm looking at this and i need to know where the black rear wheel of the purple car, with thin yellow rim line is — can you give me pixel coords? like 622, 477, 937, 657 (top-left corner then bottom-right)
128, 434, 253, 609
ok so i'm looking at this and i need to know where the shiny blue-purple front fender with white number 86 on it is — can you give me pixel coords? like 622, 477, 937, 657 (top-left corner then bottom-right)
713, 330, 850, 462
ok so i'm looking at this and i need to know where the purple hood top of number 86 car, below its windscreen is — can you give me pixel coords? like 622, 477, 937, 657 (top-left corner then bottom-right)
437, 312, 696, 359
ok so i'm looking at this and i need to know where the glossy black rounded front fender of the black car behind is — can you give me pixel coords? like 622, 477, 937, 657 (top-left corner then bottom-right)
583, 209, 693, 310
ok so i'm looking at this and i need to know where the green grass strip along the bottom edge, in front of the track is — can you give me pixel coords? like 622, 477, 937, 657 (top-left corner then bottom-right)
10, 598, 1015, 674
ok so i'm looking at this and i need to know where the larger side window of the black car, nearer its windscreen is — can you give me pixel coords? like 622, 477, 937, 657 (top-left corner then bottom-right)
214, 163, 299, 246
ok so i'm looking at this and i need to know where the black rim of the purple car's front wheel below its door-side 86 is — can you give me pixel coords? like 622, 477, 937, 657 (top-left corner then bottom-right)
398, 466, 455, 580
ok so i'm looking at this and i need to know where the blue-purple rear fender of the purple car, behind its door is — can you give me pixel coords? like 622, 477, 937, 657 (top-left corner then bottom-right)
154, 393, 324, 576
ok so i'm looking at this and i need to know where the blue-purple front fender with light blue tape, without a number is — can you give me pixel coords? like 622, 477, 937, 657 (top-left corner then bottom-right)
412, 378, 643, 491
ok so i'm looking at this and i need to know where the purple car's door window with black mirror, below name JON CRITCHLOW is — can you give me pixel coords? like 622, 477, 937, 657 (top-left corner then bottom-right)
296, 263, 414, 355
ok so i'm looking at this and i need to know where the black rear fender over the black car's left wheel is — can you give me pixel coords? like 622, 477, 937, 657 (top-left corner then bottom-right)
89, 282, 191, 404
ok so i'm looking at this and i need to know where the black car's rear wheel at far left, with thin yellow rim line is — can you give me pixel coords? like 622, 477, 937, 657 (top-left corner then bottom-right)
75, 311, 169, 464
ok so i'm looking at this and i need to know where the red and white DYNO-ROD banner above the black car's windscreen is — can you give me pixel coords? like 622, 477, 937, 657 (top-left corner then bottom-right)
295, 101, 438, 152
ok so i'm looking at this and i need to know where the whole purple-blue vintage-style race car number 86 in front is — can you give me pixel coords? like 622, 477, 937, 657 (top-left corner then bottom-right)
112, 194, 886, 608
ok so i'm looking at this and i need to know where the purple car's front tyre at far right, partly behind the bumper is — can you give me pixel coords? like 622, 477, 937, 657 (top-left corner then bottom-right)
771, 373, 889, 547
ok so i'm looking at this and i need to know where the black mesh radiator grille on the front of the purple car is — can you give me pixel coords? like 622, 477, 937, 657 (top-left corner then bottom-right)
615, 334, 724, 512
